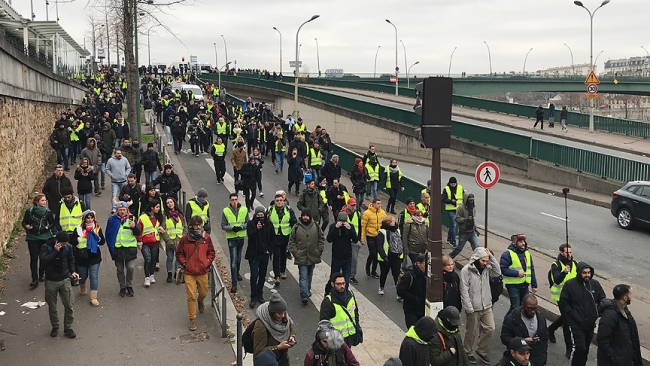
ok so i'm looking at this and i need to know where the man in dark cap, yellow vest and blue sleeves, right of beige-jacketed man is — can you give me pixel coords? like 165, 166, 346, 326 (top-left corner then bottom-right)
499, 234, 537, 313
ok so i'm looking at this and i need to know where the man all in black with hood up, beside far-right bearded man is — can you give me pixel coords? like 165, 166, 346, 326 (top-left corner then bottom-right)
559, 262, 605, 366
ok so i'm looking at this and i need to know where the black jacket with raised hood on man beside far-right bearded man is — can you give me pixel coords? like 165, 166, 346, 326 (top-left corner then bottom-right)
558, 262, 605, 331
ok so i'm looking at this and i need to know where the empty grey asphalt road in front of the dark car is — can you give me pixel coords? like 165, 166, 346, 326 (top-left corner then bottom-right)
372, 159, 650, 286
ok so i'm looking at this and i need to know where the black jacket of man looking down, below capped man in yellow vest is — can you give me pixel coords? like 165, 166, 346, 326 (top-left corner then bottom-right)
501, 307, 548, 366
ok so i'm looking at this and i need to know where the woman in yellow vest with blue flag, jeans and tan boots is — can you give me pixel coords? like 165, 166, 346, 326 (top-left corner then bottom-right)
70, 210, 106, 306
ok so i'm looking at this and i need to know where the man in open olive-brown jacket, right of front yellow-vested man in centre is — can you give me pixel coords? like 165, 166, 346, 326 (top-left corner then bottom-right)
289, 208, 325, 305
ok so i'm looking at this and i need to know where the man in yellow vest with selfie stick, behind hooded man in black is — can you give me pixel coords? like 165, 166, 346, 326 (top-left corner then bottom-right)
548, 243, 578, 352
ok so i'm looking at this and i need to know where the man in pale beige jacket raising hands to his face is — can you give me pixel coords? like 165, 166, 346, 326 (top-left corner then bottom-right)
460, 247, 501, 364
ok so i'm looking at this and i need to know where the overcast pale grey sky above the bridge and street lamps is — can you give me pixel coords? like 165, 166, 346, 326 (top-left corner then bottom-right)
13, 0, 650, 75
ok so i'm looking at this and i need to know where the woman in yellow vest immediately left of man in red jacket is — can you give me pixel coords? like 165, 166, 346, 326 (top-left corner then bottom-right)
161, 197, 187, 283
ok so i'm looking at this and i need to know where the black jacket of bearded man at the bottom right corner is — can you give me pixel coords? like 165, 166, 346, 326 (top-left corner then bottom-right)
596, 299, 643, 366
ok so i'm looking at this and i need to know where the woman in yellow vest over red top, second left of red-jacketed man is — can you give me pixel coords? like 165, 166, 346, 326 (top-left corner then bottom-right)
137, 201, 165, 287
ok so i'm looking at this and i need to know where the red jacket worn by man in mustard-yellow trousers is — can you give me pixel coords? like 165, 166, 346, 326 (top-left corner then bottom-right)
176, 232, 216, 276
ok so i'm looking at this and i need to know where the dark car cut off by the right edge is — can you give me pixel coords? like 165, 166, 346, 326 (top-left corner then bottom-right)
611, 181, 650, 229
